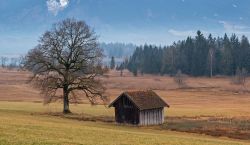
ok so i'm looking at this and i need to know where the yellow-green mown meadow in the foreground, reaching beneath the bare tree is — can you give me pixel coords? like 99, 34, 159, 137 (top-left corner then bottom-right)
0, 102, 249, 145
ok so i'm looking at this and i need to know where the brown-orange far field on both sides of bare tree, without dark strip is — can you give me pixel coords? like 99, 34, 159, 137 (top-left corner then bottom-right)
0, 70, 250, 117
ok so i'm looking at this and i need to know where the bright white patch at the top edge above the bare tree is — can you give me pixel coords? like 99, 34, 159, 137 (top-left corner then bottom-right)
47, 0, 69, 16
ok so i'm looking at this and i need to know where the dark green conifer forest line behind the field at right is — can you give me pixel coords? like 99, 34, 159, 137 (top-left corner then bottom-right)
120, 31, 250, 76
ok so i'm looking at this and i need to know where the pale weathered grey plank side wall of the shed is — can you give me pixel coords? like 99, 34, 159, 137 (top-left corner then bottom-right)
139, 108, 164, 125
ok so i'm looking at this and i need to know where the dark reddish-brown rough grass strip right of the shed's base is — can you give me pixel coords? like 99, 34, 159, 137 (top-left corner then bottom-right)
160, 116, 250, 140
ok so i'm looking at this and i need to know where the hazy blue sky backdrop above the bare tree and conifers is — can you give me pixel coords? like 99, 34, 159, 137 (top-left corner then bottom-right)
0, 0, 250, 55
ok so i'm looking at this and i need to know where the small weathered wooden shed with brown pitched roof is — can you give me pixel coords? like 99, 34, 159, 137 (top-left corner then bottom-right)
109, 90, 169, 125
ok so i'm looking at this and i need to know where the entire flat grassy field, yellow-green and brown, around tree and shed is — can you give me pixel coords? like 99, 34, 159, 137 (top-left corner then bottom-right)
0, 70, 250, 145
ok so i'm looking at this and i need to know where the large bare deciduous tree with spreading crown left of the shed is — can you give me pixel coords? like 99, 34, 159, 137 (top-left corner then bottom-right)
24, 19, 107, 113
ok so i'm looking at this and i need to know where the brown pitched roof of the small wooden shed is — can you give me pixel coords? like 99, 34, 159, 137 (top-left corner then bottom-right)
109, 90, 169, 110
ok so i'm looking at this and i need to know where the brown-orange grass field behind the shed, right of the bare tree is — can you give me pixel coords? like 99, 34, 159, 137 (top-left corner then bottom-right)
104, 72, 250, 117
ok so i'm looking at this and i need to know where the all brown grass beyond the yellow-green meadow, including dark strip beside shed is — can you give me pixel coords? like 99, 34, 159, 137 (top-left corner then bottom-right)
0, 69, 250, 140
